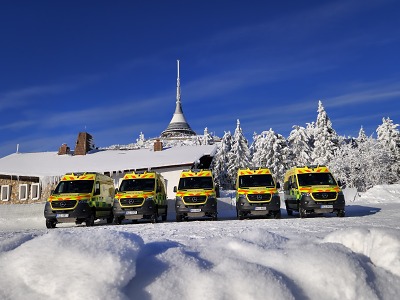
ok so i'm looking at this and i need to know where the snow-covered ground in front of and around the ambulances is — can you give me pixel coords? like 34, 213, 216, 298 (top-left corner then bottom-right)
0, 185, 400, 300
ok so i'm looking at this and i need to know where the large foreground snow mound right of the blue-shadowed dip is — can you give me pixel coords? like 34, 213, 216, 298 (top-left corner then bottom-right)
142, 229, 400, 299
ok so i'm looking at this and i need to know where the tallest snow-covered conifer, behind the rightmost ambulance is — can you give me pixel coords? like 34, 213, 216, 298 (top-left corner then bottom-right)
312, 101, 338, 165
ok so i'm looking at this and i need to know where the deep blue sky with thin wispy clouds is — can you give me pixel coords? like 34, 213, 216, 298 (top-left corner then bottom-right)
0, 0, 400, 157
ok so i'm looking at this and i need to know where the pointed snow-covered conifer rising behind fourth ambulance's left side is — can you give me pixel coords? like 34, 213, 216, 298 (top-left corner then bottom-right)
228, 120, 251, 186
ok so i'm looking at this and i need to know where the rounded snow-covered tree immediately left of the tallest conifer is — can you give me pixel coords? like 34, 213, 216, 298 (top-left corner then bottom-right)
287, 125, 312, 168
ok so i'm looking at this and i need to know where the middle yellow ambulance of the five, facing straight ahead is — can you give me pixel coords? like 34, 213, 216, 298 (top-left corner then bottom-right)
174, 169, 219, 222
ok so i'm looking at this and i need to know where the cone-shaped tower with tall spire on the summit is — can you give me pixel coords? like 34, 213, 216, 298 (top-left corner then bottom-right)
161, 60, 196, 138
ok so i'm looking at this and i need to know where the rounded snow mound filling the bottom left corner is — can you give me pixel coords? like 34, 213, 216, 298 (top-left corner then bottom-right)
0, 228, 143, 299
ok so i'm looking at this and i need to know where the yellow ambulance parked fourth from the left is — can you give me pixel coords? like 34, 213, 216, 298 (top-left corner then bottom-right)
236, 168, 281, 220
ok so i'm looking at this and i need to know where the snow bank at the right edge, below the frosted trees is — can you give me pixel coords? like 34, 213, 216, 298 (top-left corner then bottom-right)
358, 184, 400, 203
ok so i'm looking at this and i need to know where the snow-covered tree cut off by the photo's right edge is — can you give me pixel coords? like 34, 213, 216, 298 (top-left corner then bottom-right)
376, 118, 400, 180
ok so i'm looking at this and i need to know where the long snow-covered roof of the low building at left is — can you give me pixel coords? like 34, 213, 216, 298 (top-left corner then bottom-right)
0, 145, 216, 177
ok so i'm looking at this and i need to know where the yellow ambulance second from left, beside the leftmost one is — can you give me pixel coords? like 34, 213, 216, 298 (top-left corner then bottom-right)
113, 171, 168, 224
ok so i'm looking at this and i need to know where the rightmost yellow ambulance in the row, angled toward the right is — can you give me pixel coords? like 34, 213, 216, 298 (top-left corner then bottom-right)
284, 166, 345, 218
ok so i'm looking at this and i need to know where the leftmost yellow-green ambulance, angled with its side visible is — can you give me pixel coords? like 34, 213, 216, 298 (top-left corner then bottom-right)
44, 172, 115, 228
